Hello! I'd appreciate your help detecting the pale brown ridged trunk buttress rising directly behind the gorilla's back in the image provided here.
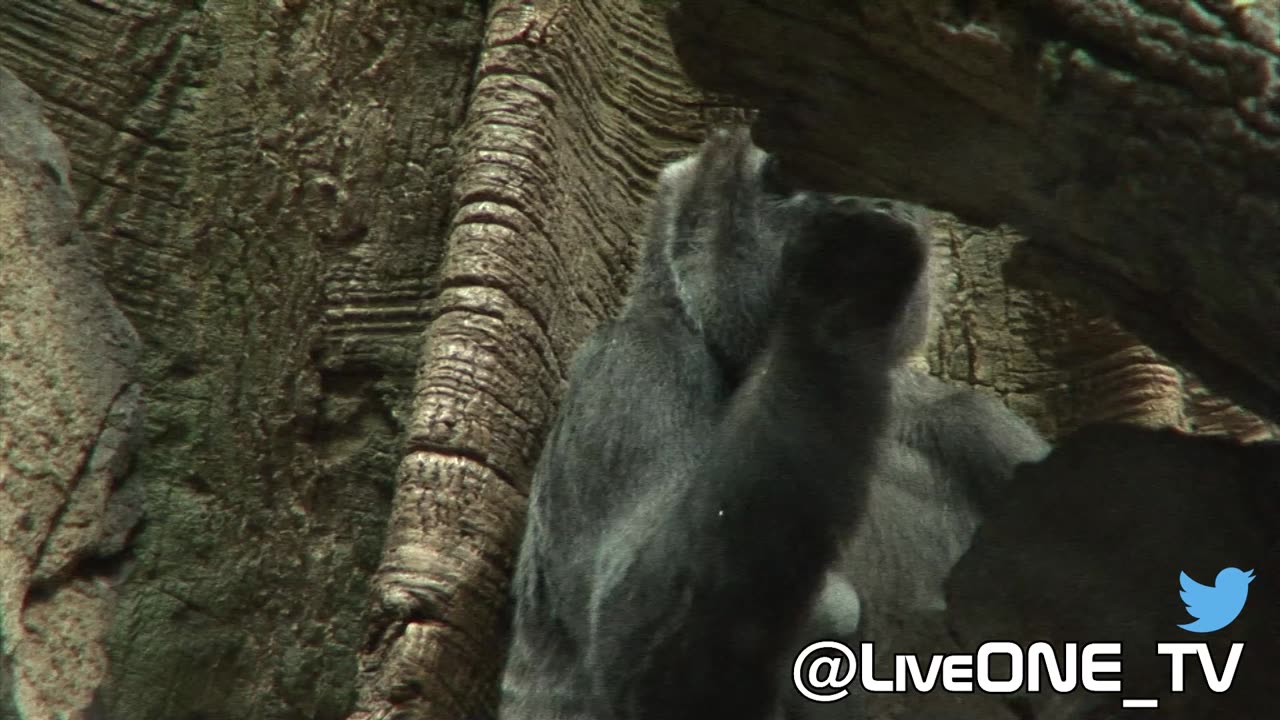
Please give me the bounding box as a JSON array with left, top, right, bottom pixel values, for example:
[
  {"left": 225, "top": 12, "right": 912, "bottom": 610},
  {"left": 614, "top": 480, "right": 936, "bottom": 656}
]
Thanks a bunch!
[{"left": 355, "top": 1, "right": 721, "bottom": 720}]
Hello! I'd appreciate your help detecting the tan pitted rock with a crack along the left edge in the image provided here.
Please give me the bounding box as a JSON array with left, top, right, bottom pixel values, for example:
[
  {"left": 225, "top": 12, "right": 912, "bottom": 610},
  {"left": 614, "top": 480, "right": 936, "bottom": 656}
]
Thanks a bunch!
[{"left": 0, "top": 68, "right": 142, "bottom": 720}]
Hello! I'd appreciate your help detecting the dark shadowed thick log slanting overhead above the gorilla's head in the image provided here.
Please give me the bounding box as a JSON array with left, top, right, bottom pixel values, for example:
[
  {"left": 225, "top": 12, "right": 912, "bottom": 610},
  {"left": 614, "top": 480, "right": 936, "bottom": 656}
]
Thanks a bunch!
[{"left": 672, "top": 0, "right": 1280, "bottom": 419}]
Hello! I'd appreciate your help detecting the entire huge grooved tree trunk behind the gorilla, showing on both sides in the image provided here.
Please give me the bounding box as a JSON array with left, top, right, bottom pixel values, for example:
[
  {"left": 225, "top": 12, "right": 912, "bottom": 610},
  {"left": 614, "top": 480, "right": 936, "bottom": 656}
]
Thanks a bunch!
[{"left": 0, "top": 0, "right": 1274, "bottom": 720}]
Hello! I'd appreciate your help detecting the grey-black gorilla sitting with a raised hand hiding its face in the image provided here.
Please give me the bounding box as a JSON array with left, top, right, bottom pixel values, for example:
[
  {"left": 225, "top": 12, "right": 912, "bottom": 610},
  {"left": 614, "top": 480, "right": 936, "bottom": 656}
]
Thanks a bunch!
[{"left": 500, "top": 132, "right": 1044, "bottom": 720}]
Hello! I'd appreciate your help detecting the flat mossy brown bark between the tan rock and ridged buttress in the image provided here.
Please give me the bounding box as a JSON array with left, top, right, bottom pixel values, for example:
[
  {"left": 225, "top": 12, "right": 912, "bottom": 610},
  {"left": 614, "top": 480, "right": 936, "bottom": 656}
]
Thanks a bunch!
[{"left": 0, "top": 0, "right": 484, "bottom": 720}]
